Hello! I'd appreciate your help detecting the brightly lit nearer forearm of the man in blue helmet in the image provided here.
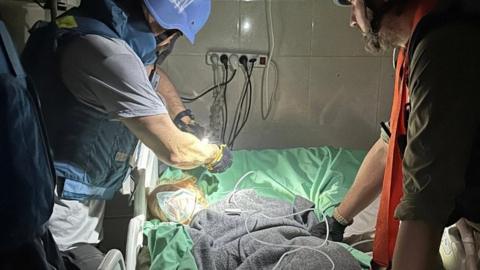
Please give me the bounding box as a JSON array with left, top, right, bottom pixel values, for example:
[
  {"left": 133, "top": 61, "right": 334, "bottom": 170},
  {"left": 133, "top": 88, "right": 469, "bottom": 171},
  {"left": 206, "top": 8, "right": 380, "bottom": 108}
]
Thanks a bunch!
[{"left": 122, "top": 114, "right": 220, "bottom": 169}]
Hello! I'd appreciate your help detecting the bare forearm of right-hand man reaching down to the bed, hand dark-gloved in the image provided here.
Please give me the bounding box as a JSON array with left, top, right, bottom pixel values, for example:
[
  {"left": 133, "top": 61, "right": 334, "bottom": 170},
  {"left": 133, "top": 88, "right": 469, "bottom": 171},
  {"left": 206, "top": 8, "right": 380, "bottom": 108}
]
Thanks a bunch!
[{"left": 337, "top": 139, "right": 387, "bottom": 220}]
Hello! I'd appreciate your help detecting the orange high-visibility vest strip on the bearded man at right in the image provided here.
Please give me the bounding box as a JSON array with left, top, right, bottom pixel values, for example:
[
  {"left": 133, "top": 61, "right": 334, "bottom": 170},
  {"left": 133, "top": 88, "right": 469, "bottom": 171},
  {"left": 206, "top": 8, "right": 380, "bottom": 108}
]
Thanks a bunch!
[{"left": 373, "top": 0, "right": 436, "bottom": 267}]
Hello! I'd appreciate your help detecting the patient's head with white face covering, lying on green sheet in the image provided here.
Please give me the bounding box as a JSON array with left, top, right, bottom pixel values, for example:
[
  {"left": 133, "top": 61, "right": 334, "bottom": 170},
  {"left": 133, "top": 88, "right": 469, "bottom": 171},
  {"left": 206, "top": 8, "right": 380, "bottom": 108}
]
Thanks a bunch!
[{"left": 147, "top": 176, "right": 208, "bottom": 224}]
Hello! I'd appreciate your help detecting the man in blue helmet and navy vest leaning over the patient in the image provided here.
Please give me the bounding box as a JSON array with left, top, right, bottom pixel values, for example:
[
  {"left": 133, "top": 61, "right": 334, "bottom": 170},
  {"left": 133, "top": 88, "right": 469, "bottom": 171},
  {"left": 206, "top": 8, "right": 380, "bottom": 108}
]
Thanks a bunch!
[{"left": 22, "top": 0, "right": 231, "bottom": 269}]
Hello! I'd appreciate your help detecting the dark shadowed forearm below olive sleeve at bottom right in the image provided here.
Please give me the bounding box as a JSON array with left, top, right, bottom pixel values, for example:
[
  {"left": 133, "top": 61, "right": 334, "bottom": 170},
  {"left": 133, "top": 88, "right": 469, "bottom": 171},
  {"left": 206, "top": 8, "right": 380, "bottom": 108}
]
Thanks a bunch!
[{"left": 392, "top": 220, "right": 443, "bottom": 270}]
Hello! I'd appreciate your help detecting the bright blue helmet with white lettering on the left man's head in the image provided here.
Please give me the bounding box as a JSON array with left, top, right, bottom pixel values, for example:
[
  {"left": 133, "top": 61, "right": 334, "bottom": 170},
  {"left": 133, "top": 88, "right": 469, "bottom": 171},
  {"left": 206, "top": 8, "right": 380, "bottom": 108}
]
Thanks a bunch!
[{"left": 143, "top": 0, "right": 211, "bottom": 44}]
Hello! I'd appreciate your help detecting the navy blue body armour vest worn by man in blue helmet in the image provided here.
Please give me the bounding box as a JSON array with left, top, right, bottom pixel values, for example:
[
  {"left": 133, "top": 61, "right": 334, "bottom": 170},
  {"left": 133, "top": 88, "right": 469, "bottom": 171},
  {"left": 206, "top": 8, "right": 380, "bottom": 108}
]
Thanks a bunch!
[{"left": 22, "top": 0, "right": 156, "bottom": 200}]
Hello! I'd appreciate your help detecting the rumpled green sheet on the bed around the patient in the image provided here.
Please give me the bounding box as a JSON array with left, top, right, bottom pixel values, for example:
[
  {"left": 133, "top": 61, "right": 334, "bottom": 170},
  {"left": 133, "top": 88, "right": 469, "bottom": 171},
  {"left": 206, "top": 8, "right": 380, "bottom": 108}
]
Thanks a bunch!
[{"left": 144, "top": 147, "right": 371, "bottom": 269}]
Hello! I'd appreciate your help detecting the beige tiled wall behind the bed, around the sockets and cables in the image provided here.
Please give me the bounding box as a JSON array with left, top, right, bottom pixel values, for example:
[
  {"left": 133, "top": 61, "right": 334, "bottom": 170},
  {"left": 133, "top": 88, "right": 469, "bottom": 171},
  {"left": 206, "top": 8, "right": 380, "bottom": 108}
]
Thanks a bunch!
[{"left": 164, "top": 0, "right": 393, "bottom": 149}]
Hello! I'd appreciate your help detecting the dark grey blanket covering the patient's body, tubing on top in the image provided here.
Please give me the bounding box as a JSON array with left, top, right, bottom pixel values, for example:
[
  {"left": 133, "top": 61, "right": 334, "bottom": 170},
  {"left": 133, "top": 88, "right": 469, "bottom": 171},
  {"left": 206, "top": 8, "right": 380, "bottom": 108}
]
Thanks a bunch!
[{"left": 188, "top": 190, "right": 360, "bottom": 270}]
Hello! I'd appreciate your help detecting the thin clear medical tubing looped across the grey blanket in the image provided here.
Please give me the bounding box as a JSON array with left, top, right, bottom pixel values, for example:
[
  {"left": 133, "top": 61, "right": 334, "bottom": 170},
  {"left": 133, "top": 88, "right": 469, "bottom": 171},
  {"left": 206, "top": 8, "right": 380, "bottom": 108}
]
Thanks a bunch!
[{"left": 228, "top": 171, "right": 335, "bottom": 270}]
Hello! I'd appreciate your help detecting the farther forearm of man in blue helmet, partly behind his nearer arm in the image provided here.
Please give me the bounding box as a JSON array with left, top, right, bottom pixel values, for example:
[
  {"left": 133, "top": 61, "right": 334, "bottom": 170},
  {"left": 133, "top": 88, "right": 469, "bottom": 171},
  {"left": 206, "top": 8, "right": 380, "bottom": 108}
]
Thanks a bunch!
[{"left": 147, "top": 67, "right": 185, "bottom": 118}]
